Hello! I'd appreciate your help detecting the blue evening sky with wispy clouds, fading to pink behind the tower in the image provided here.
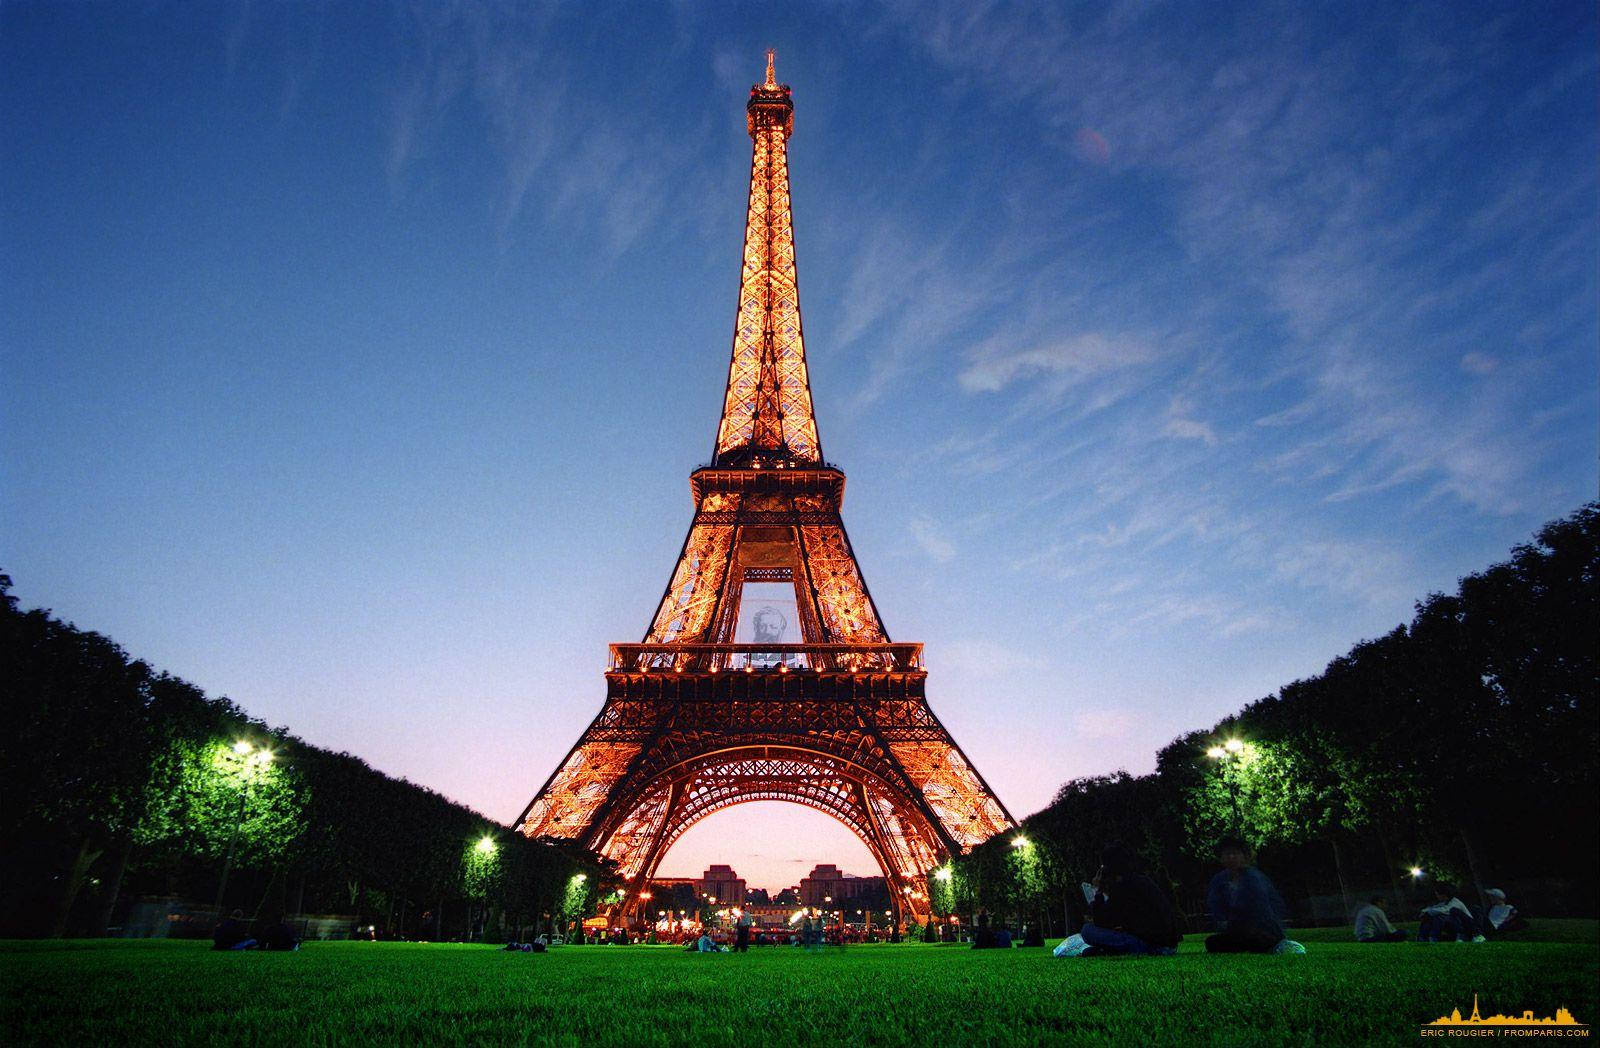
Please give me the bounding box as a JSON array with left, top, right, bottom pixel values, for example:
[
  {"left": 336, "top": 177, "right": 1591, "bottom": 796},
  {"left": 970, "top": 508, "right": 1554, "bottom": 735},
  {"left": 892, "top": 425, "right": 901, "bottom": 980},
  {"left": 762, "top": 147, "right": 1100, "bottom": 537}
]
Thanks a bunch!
[{"left": 0, "top": 2, "right": 1600, "bottom": 886}]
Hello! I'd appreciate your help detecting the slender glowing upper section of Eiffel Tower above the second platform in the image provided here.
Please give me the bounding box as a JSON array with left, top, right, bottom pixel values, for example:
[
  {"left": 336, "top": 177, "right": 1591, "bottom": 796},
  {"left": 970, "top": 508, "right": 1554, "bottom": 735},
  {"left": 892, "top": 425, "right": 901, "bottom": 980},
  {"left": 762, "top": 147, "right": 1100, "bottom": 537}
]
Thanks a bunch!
[{"left": 714, "top": 50, "right": 822, "bottom": 469}]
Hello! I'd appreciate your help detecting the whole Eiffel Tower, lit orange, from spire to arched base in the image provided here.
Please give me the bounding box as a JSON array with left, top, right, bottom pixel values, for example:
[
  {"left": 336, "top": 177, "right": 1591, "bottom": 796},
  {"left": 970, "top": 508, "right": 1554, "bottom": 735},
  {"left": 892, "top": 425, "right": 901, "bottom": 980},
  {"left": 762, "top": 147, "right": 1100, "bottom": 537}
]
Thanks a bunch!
[{"left": 517, "top": 51, "right": 1014, "bottom": 918}]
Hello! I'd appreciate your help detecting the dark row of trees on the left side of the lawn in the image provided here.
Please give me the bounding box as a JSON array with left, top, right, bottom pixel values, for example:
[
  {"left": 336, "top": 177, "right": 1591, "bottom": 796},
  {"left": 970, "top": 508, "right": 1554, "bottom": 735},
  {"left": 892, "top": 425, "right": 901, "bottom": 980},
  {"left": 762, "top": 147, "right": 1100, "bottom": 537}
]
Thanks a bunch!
[{"left": 0, "top": 574, "right": 613, "bottom": 939}]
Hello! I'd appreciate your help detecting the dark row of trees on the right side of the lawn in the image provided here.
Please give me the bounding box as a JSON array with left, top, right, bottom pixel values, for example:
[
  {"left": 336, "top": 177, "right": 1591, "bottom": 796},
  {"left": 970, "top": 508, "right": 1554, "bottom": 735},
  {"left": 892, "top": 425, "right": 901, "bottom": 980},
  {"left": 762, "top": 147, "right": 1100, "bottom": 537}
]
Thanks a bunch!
[{"left": 933, "top": 504, "right": 1600, "bottom": 928}]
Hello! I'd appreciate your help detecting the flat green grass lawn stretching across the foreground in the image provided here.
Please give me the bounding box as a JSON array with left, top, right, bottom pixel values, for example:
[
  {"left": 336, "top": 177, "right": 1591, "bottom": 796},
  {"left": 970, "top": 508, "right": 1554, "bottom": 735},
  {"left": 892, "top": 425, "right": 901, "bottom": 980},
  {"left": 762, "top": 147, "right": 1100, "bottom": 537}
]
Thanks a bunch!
[{"left": 0, "top": 922, "right": 1600, "bottom": 1048}]
